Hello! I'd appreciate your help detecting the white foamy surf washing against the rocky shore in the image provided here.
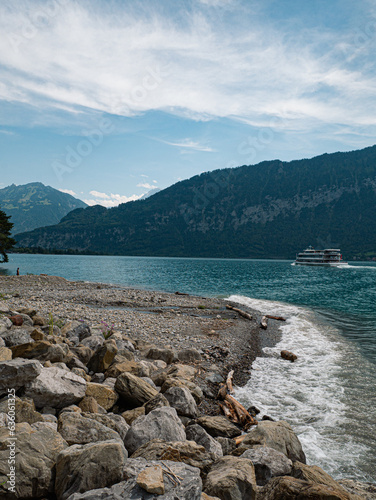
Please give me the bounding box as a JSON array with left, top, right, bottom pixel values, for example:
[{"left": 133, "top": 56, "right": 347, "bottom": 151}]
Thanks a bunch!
[{"left": 229, "top": 295, "right": 376, "bottom": 481}]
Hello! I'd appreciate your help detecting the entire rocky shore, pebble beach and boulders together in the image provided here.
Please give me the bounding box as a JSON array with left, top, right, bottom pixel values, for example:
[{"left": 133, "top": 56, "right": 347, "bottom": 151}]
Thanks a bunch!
[{"left": 0, "top": 275, "right": 376, "bottom": 500}]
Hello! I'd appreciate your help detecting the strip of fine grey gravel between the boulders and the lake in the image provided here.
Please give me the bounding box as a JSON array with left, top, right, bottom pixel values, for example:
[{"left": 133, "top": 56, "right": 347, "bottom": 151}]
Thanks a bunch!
[{"left": 0, "top": 275, "right": 280, "bottom": 408}]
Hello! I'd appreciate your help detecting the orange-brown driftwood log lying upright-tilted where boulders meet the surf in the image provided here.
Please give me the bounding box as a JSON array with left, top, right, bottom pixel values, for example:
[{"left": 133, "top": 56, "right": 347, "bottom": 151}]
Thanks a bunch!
[{"left": 217, "top": 370, "right": 257, "bottom": 430}]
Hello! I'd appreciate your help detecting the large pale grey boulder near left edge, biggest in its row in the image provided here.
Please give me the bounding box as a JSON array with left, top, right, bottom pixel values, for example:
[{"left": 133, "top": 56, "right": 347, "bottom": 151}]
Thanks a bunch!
[{"left": 24, "top": 366, "right": 86, "bottom": 408}]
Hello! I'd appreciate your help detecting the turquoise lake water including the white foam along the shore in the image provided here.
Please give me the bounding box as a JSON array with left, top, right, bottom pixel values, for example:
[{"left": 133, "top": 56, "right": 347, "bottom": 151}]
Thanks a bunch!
[{"left": 0, "top": 254, "right": 376, "bottom": 481}]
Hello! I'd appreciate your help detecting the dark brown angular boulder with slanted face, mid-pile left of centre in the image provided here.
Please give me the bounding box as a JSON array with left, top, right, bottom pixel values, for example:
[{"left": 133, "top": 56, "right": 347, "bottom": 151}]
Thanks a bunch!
[{"left": 115, "top": 372, "right": 158, "bottom": 408}]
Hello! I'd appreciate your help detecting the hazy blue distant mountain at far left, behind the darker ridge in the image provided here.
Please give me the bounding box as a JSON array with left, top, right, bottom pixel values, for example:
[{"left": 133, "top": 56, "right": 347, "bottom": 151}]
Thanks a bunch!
[{"left": 0, "top": 182, "right": 87, "bottom": 234}]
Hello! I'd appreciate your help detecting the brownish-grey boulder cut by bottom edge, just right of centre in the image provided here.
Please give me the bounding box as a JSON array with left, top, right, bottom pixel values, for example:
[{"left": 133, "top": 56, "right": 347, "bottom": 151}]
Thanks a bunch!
[{"left": 204, "top": 456, "right": 257, "bottom": 500}]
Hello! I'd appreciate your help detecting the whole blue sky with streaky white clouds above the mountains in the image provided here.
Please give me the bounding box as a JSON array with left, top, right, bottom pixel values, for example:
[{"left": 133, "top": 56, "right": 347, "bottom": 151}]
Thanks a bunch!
[{"left": 0, "top": 0, "right": 376, "bottom": 207}]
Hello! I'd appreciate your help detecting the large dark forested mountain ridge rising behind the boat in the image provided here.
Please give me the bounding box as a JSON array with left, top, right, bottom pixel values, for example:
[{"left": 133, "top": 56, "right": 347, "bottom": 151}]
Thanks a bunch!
[{"left": 16, "top": 146, "right": 376, "bottom": 259}]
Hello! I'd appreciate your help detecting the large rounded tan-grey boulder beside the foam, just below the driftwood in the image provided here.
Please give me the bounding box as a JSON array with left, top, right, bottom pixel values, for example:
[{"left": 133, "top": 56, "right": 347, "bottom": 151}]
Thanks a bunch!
[{"left": 236, "top": 420, "right": 306, "bottom": 463}]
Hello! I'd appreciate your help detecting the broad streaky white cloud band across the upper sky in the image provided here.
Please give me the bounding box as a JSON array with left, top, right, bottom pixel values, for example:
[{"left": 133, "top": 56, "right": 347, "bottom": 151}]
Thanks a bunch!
[{"left": 0, "top": 0, "right": 376, "bottom": 135}]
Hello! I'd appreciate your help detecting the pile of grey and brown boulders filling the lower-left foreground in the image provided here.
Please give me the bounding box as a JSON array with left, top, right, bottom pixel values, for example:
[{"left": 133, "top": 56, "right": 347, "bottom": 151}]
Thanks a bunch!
[{"left": 0, "top": 280, "right": 370, "bottom": 500}]
